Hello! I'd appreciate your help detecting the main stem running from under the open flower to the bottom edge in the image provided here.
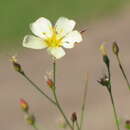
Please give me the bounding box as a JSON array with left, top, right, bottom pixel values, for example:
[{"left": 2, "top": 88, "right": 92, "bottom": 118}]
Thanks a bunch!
[{"left": 53, "top": 59, "right": 73, "bottom": 130}]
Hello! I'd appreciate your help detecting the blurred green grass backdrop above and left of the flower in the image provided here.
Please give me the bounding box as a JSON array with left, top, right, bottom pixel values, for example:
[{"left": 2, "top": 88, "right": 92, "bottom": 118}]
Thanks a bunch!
[{"left": 0, "top": 0, "right": 128, "bottom": 50}]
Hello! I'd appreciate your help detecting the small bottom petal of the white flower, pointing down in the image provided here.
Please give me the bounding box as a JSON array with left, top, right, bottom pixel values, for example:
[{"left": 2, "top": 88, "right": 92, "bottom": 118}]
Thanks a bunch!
[{"left": 47, "top": 47, "right": 65, "bottom": 59}]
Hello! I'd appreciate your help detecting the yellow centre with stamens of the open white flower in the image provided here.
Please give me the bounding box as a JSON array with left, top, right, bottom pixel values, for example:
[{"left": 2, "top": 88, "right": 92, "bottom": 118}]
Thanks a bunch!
[{"left": 45, "top": 28, "right": 62, "bottom": 48}]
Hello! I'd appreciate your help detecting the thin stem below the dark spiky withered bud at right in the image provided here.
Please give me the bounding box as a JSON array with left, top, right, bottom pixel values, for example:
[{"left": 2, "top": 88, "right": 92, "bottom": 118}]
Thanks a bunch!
[{"left": 109, "top": 90, "right": 120, "bottom": 130}]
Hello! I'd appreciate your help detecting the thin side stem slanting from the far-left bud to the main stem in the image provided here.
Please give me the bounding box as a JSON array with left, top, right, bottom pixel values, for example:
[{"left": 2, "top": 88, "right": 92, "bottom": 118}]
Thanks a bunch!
[{"left": 21, "top": 73, "right": 56, "bottom": 105}]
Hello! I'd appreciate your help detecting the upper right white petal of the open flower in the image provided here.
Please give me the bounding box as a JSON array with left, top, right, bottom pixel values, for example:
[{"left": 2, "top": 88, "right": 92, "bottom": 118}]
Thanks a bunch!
[{"left": 55, "top": 17, "right": 76, "bottom": 37}]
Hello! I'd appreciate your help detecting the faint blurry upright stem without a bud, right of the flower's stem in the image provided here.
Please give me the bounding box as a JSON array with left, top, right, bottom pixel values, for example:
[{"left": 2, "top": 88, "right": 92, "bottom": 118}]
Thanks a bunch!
[{"left": 80, "top": 76, "right": 88, "bottom": 130}]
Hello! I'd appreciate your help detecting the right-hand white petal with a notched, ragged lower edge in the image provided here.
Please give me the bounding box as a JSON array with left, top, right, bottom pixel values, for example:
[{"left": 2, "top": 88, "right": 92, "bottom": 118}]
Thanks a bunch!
[{"left": 62, "top": 31, "right": 82, "bottom": 48}]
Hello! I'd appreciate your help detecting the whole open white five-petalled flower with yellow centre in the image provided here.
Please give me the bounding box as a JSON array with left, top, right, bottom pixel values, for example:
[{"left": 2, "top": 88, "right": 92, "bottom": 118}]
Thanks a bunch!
[{"left": 23, "top": 17, "right": 82, "bottom": 59}]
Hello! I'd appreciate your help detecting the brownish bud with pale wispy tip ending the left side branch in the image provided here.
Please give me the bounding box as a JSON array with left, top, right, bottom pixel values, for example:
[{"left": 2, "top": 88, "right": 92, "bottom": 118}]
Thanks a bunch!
[{"left": 11, "top": 56, "right": 24, "bottom": 74}]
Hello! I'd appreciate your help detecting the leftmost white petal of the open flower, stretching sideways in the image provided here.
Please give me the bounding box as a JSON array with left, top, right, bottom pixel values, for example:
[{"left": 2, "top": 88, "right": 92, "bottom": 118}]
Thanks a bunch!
[{"left": 23, "top": 35, "right": 46, "bottom": 49}]
